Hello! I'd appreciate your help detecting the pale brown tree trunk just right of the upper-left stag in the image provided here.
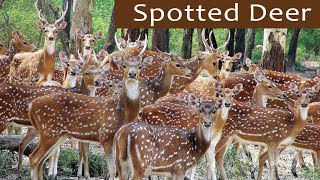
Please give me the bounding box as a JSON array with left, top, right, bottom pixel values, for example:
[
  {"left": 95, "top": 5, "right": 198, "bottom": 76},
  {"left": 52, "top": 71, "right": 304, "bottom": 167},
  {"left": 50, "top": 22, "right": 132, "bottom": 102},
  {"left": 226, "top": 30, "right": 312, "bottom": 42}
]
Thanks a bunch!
[{"left": 70, "top": 0, "right": 93, "bottom": 57}]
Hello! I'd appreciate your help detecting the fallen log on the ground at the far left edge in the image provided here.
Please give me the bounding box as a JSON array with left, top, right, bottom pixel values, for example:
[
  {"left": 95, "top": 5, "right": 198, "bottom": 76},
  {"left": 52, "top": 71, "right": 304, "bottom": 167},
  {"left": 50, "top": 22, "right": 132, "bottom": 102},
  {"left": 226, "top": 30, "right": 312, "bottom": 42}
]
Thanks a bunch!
[{"left": 0, "top": 135, "right": 38, "bottom": 156}]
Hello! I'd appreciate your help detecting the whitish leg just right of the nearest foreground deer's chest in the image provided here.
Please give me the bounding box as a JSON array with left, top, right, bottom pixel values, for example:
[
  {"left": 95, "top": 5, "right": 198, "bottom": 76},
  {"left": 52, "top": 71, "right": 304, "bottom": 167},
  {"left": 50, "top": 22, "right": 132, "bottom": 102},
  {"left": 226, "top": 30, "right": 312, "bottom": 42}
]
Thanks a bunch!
[{"left": 205, "top": 143, "right": 217, "bottom": 180}]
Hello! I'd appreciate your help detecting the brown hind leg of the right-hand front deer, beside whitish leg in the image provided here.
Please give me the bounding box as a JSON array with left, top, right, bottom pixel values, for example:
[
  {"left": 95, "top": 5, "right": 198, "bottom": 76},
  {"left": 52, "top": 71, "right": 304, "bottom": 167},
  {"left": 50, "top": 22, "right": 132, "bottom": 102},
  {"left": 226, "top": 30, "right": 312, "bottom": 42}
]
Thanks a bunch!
[{"left": 216, "top": 138, "right": 232, "bottom": 180}]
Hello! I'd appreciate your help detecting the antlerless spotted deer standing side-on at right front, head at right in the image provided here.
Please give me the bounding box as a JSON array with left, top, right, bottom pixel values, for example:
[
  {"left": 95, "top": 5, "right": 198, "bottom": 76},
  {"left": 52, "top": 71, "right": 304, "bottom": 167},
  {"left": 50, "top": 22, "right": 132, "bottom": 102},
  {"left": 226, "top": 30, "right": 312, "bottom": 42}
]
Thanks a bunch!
[{"left": 216, "top": 83, "right": 319, "bottom": 179}]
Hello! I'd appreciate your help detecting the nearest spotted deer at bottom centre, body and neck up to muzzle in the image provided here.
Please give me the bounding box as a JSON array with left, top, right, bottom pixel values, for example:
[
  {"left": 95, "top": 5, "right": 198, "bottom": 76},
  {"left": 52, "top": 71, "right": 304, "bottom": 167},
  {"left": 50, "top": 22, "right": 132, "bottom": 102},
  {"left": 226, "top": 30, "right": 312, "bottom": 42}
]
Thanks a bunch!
[{"left": 114, "top": 118, "right": 212, "bottom": 180}]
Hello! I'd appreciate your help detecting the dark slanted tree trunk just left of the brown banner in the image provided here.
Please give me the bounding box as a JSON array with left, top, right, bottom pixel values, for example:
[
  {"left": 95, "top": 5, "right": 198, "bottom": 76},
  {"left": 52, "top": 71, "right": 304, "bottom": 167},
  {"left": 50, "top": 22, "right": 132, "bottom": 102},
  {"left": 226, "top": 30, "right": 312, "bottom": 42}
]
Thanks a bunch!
[{"left": 103, "top": 7, "right": 117, "bottom": 53}]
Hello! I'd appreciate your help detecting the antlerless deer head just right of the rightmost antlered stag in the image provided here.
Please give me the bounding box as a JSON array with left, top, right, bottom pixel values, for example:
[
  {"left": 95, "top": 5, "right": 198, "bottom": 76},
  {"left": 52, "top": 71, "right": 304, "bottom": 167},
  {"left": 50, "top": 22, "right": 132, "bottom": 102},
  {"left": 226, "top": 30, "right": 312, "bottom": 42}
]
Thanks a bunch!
[{"left": 219, "top": 51, "right": 242, "bottom": 80}]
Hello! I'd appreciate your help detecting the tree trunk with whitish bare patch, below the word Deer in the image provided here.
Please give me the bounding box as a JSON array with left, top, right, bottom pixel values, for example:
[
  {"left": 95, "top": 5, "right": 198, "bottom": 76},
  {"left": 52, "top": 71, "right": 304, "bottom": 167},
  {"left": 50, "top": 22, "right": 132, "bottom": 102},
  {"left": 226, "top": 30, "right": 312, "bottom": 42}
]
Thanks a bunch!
[{"left": 261, "top": 29, "right": 287, "bottom": 72}]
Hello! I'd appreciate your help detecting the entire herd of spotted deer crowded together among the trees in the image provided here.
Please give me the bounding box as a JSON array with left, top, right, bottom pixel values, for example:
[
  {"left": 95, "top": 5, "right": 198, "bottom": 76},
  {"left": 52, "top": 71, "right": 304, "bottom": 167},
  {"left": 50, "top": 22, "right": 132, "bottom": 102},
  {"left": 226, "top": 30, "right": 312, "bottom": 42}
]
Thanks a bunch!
[{"left": 0, "top": 1, "right": 320, "bottom": 179}]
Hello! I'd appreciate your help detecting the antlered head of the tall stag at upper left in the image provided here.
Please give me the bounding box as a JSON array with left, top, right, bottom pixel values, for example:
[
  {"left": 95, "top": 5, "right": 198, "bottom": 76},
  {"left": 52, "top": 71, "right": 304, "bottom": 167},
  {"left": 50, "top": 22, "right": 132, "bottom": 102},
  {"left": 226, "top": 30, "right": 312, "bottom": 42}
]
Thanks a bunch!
[{"left": 35, "top": 0, "right": 68, "bottom": 47}]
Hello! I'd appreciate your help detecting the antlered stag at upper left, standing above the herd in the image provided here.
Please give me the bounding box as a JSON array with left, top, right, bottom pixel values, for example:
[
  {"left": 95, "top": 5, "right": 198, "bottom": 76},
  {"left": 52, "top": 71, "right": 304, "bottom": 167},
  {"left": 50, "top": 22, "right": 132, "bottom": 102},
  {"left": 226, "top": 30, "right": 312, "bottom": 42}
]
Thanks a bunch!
[{"left": 9, "top": 2, "right": 68, "bottom": 85}]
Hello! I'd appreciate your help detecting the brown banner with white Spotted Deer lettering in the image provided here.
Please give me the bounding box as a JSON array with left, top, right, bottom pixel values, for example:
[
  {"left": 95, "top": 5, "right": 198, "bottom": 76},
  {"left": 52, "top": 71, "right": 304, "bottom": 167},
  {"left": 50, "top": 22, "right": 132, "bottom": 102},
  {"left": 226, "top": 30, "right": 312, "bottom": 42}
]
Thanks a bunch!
[{"left": 115, "top": 0, "right": 320, "bottom": 28}]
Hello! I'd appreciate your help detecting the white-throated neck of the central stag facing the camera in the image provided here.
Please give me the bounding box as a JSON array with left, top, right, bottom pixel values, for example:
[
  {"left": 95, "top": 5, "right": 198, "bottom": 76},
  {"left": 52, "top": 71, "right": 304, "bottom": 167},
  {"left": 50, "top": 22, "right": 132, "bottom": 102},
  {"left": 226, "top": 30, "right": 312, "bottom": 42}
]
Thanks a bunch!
[{"left": 120, "top": 79, "right": 141, "bottom": 123}]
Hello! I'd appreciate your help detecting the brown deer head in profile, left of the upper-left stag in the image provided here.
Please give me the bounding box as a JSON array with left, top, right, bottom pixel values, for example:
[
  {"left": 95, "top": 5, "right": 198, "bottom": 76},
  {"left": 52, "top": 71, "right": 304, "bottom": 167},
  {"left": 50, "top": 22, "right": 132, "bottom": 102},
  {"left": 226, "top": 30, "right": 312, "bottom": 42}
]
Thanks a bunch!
[{"left": 10, "top": 29, "right": 37, "bottom": 54}]
